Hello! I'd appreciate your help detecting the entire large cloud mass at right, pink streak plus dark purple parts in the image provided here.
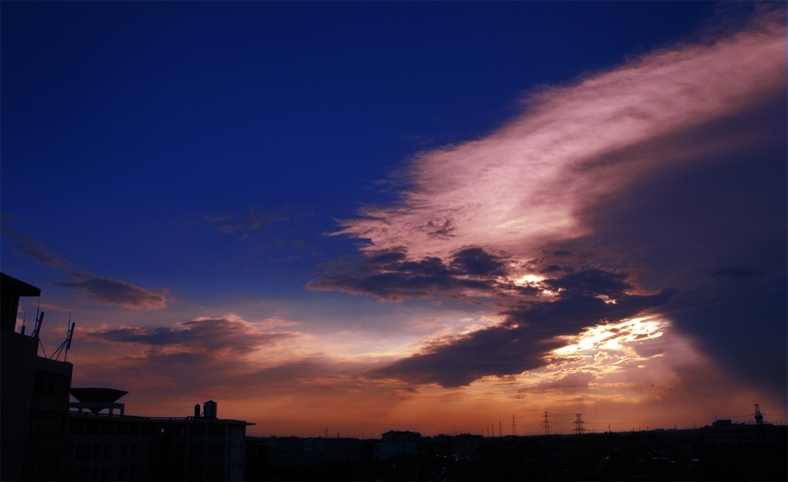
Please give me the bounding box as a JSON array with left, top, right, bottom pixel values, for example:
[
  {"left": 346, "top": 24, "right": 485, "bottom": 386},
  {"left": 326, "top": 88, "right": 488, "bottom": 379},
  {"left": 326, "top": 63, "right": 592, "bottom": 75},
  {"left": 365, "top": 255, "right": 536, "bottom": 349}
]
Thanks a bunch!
[{"left": 318, "top": 9, "right": 788, "bottom": 398}]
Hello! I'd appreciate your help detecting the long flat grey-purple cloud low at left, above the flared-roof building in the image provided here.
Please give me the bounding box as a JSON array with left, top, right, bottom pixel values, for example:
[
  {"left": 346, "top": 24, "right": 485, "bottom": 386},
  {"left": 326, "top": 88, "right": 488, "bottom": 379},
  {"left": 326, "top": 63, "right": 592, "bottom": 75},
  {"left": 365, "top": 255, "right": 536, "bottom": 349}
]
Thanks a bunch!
[{"left": 90, "top": 318, "right": 298, "bottom": 356}]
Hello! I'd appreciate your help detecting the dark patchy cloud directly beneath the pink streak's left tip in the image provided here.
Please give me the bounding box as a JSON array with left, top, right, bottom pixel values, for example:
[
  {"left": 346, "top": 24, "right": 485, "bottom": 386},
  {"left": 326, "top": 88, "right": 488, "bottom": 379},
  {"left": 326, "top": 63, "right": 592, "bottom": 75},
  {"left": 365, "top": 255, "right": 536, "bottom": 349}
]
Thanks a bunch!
[{"left": 307, "top": 247, "right": 516, "bottom": 301}]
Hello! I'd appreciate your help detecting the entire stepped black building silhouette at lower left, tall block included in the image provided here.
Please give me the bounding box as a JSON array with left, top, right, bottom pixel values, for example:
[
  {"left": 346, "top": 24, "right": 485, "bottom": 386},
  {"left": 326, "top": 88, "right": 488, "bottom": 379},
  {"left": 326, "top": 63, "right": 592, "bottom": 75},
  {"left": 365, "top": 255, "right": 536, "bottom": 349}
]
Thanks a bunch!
[{"left": 0, "top": 274, "right": 253, "bottom": 481}]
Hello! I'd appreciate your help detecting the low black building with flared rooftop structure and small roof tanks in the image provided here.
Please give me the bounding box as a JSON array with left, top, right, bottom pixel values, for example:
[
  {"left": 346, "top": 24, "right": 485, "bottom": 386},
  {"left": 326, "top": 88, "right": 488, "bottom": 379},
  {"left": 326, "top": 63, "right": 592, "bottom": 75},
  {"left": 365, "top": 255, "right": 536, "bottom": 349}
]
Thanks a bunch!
[{"left": 64, "top": 394, "right": 253, "bottom": 480}]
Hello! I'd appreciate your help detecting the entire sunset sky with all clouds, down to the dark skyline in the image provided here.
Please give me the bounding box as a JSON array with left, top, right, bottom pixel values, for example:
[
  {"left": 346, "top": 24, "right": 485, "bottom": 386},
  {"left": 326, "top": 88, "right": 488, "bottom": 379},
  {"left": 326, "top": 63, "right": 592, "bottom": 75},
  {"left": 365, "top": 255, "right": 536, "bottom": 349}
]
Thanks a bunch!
[{"left": 0, "top": 1, "right": 788, "bottom": 438}]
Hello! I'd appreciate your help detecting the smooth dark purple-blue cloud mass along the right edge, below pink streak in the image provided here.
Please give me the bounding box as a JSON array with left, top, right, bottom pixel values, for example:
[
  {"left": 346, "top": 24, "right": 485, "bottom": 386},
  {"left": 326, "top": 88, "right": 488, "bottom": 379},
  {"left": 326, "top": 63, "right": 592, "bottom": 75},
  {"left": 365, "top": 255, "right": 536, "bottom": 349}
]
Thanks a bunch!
[{"left": 572, "top": 94, "right": 788, "bottom": 400}]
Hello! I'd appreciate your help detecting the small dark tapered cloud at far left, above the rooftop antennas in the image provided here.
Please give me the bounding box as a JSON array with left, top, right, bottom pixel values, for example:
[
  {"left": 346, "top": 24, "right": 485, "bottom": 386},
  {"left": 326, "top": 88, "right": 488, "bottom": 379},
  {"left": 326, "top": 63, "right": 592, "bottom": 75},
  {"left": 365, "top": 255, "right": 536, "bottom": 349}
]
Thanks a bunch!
[{"left": 55, "top": 273, "right": 167, "bottom": 309}]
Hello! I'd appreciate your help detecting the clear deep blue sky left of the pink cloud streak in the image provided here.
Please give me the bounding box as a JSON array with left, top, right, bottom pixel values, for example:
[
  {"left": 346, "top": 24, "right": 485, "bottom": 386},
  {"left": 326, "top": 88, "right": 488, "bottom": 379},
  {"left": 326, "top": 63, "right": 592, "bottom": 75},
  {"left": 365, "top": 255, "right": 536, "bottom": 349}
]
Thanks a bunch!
[{"left": 2, "top": 2, "right": 714, "bottom": 296}]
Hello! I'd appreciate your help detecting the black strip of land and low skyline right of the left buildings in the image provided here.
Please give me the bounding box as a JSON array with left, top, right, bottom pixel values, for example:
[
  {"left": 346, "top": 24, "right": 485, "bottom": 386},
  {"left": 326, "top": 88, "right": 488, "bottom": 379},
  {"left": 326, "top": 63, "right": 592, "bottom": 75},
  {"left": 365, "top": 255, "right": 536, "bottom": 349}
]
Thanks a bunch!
[{"left": 246, "top": 426, "right": 788, "bottom": 481}]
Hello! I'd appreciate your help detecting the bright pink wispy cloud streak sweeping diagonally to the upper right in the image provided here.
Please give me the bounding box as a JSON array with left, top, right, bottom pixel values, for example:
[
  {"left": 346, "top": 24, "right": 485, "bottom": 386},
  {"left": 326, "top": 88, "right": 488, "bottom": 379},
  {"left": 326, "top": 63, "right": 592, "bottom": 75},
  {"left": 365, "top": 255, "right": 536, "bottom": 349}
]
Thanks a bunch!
[{"left": 341, "top": 12, "right": 785, "bottom": 259}]
